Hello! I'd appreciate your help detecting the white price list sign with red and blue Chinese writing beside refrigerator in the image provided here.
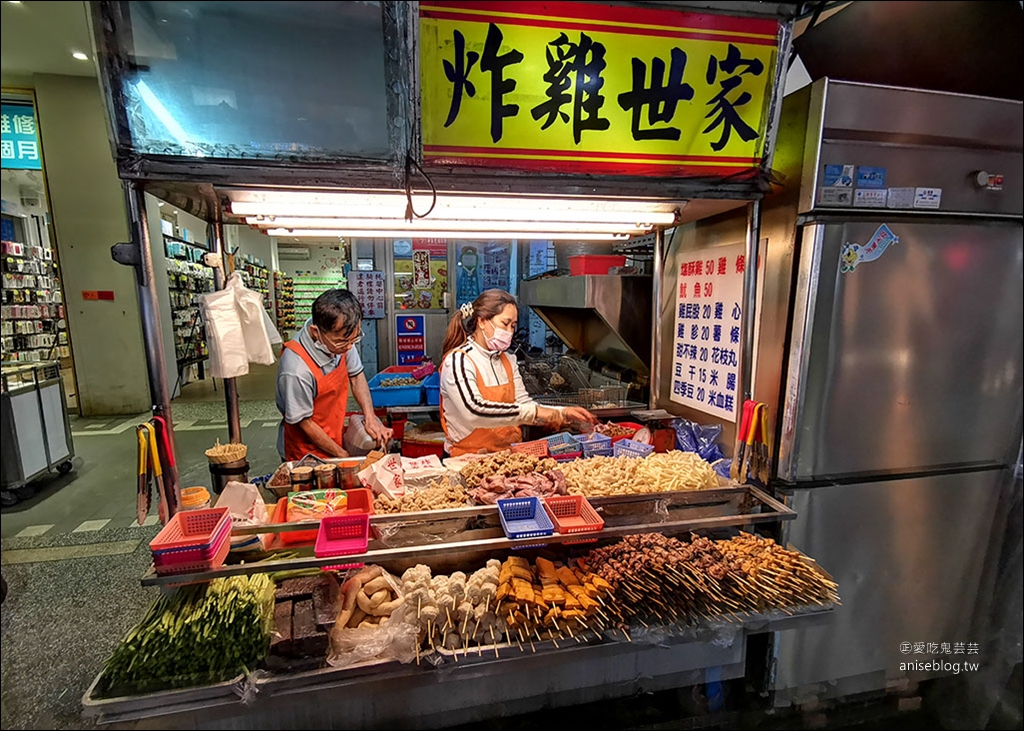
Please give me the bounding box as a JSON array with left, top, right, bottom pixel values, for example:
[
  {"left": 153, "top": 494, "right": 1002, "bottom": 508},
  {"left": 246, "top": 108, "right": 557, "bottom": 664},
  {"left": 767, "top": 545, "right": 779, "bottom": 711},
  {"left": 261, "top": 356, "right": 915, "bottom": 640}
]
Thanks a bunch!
[{"left": 670, "top": 244, "right": 745, "bottom": 421}]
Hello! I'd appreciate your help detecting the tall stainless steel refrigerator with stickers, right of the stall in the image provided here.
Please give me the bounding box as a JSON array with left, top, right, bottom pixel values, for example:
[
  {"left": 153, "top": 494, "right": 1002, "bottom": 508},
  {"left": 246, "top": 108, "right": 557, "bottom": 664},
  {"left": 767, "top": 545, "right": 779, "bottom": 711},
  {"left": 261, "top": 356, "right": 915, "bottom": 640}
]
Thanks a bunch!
[{"left": 755, "top": 80, "right": 1024, "bottom": 702}]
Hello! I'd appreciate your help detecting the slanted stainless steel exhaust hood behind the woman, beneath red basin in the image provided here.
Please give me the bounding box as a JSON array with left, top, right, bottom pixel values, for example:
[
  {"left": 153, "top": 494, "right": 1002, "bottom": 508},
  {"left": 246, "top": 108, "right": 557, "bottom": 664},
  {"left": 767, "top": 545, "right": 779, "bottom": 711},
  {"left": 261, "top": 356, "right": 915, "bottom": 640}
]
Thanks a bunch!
[{"left": 519, "top": 275, "right": 652, "bottom": 376}]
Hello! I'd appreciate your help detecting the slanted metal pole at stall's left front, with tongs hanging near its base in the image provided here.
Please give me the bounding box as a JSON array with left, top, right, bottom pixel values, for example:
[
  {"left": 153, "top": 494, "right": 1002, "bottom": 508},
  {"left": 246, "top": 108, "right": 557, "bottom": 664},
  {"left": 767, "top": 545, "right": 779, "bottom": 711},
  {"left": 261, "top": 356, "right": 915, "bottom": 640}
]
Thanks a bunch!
[{"left": 121, "top": 182, "right": 178, "bottom": 517}]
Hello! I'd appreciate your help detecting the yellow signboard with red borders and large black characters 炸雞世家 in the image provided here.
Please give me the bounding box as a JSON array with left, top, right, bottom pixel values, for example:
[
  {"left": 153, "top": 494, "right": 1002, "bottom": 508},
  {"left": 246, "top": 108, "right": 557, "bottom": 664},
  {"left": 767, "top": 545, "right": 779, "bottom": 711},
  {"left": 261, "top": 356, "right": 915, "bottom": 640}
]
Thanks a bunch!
[{"left": 420, "top": 0, "right": 778, "bottom": 176}]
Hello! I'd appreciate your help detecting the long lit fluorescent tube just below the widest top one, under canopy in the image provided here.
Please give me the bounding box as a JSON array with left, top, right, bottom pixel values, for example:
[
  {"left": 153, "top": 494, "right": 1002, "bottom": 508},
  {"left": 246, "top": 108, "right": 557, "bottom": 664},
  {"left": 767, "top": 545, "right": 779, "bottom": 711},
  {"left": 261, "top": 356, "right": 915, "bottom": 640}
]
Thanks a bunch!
[{"left": 246, "top": 216, "right": 652, "bottom": 237}]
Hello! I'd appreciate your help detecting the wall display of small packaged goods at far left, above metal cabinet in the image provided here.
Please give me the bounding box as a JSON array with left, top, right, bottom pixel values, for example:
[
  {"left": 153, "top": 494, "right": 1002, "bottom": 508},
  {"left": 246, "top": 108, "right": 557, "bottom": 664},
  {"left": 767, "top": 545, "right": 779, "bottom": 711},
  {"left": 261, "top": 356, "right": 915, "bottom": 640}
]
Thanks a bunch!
[{"left": 0, "top": 241, "right": 71, "bottom": 362}]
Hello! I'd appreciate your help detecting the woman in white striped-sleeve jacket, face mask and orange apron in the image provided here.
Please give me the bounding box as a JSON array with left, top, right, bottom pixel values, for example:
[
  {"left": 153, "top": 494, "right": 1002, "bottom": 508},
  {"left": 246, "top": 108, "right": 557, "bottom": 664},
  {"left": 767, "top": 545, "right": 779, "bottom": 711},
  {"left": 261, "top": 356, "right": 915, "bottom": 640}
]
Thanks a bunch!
[{"left": 440, "top": 290, "right": 597, "bottom": 457}]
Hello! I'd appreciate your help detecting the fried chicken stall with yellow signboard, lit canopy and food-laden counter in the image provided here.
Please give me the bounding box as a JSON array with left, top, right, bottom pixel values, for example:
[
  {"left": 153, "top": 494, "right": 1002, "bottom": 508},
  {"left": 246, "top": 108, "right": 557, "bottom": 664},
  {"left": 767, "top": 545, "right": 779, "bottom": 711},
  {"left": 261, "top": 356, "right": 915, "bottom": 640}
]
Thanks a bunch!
[{"left": 70, "top": 1, "right": 864, "bottom": 728}]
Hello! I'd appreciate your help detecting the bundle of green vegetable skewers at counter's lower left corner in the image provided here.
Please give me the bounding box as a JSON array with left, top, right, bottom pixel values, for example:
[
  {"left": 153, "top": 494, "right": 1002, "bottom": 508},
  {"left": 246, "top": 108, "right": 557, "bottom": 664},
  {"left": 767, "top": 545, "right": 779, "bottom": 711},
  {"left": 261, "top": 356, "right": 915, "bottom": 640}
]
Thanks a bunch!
[{"left": 101, "top": 573, "right": 274, "bottom": 695}]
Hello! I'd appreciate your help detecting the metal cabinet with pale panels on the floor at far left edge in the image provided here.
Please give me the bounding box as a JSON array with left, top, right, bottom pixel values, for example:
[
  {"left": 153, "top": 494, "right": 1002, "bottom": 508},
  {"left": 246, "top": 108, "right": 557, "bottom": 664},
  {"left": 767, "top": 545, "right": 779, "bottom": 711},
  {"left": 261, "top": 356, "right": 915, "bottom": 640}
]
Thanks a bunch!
[{"left": 0, "top": 360, "right": 75, "bottom": 505}]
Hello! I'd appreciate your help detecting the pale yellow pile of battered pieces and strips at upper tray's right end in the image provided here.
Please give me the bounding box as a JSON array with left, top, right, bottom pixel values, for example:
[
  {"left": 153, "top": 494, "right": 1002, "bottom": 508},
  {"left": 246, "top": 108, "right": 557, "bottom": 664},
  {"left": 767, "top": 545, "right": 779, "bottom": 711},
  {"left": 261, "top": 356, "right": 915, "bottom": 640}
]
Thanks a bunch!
[{"left": 562, "top": 452, "right": 719, "bottom": 497}]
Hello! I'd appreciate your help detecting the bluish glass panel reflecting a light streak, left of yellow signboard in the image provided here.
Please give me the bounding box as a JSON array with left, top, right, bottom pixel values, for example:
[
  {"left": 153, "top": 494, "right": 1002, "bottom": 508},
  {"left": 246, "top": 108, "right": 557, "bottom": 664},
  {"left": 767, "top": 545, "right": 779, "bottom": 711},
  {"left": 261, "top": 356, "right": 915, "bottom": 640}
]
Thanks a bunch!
[{"left": 119, "top": 0, "right": 389, "bottom": 161}]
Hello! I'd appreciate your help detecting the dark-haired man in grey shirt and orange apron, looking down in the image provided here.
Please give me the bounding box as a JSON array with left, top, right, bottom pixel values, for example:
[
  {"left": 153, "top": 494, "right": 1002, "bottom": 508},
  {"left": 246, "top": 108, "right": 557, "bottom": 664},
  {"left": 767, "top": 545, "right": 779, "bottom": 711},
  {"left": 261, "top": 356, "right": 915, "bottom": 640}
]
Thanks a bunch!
[{"left": 276, "top": 290, "right": 391, "bottom": 462}]
